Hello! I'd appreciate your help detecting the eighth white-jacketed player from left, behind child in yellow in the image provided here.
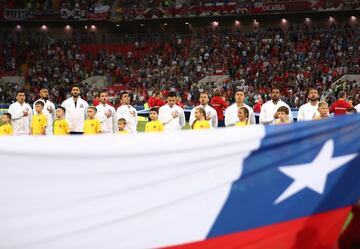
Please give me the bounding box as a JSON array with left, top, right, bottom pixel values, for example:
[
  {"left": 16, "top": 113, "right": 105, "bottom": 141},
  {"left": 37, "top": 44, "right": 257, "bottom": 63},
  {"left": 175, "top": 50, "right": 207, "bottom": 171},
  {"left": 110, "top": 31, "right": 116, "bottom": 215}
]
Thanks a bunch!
[{"left": 225, "top": 91, "right": 256, "bottom": 126}]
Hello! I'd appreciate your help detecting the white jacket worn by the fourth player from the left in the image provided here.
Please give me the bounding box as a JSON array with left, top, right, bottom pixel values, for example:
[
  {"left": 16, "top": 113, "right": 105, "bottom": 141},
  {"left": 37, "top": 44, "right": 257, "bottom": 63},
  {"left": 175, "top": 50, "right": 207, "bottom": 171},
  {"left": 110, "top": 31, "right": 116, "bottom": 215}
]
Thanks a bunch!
[{"left": 95, "top": 103, "right": 117, "bottom": 134}]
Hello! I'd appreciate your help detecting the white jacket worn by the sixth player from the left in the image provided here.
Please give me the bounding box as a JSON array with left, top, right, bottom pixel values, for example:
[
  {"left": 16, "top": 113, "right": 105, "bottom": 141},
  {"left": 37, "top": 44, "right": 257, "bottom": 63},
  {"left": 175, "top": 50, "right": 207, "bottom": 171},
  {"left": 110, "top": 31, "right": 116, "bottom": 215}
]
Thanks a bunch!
[{"left": 159, "top": 104, "right": 185, "bottom": 131}]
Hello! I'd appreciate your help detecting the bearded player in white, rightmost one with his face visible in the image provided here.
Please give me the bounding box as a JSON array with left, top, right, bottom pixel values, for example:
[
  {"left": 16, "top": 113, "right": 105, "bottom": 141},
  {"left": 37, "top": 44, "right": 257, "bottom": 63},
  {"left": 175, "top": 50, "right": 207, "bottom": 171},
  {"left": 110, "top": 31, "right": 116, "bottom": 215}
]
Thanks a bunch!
[{"left": 297, "top": 88, "right": 319, "bottom": 121}]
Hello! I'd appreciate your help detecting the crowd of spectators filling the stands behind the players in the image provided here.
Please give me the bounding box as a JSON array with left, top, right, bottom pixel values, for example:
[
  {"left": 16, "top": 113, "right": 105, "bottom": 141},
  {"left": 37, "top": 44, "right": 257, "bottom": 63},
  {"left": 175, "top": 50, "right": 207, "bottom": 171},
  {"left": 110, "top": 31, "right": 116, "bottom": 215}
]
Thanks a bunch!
[{"left": 0, "top": 22, "right": 360, "bottom": 108}]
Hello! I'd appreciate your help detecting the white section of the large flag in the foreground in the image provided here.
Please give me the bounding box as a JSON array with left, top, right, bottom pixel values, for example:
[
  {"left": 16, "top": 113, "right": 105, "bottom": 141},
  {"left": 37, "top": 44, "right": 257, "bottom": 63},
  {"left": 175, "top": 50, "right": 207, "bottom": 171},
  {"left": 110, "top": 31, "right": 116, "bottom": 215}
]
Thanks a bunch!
[{"left": 0, "top": 126, "right": 265, "bottom": 249}]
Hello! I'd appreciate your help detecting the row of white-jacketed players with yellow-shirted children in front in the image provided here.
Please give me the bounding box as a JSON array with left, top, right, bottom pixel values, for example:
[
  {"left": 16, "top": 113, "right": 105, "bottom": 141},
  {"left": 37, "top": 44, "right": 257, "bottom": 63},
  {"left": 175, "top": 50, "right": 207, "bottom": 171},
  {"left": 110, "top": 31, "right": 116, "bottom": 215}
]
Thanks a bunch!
[{"left": 0, "top": 85, "right": 360, "bottom": 135}]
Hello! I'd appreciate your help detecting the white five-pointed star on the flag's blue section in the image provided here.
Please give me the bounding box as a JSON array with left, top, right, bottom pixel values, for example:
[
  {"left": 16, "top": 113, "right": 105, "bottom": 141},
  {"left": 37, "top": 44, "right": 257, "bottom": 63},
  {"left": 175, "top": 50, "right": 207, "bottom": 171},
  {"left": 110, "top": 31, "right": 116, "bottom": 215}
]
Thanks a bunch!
[{"left": 274, "top": 140, "right": 358, "bottom": 205}]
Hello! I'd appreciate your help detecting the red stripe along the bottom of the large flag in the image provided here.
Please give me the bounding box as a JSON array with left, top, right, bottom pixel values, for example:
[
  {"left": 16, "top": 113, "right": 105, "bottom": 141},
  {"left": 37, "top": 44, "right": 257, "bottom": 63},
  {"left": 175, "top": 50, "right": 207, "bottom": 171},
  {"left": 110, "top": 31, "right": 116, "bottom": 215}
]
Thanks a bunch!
[{"left": 167, "top": 207, "right": 350, "bottom": 249}]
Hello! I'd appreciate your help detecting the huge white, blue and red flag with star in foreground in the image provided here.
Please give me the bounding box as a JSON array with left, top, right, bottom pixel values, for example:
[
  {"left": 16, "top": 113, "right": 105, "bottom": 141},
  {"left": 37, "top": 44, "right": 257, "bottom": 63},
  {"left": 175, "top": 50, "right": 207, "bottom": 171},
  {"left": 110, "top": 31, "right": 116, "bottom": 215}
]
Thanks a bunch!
[{"left": 0, "top": 115, "right": 360, "bottom": 249}]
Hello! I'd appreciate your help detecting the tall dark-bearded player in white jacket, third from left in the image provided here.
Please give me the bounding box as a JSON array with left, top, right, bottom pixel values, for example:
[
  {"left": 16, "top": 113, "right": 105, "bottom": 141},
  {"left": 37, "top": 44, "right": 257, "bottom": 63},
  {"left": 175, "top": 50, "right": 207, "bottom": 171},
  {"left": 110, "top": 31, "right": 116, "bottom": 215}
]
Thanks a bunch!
[{"left": 61, "top": 85, "right": 89, "bottom": 135}]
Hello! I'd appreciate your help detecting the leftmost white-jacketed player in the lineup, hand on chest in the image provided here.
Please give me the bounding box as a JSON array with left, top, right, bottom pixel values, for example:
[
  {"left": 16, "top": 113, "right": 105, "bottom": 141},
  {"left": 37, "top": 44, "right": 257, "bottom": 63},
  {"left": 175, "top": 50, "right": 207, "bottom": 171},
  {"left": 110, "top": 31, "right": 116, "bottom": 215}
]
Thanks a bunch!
[{"left": 9, "top": 91, "right": 32, "bottom": 135}]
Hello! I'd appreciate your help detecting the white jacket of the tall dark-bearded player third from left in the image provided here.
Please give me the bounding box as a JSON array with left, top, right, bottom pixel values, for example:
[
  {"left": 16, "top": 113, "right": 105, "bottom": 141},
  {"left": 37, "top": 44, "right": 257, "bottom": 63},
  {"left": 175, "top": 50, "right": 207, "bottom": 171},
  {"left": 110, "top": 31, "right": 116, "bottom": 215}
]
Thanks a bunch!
[{"left": 61, "top": 97, "right": 89, "bottom": 132}]
